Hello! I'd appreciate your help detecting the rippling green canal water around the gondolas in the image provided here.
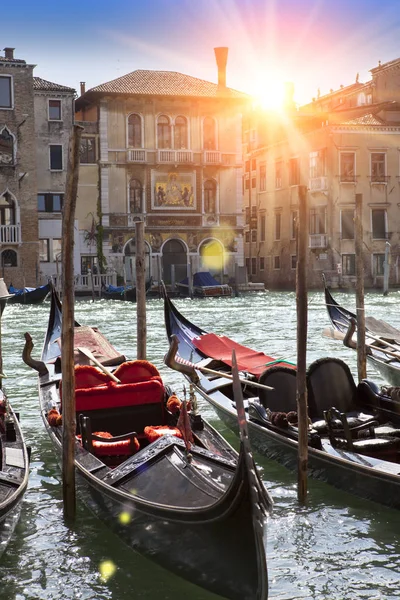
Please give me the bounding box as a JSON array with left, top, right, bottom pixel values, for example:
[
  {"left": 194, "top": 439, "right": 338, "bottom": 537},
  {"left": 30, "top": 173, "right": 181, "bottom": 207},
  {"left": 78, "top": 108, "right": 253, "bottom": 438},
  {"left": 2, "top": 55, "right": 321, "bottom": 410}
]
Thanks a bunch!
[{"left": 0, "top": 292, "right": 400, "bottom": 600}]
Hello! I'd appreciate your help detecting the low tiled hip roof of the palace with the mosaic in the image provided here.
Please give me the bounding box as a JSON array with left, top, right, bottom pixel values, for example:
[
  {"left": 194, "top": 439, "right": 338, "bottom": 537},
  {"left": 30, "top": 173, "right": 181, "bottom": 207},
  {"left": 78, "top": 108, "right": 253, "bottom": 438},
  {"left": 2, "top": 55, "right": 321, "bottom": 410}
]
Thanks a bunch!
[{"left": 86, "top": 70, "right": 249, "bottom": 99}]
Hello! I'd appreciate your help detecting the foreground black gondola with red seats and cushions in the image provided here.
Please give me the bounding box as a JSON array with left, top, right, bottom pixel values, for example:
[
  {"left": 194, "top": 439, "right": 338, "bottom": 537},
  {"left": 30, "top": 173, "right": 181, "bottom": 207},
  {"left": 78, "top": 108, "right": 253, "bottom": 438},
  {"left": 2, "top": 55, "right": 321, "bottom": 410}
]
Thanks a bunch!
[{"left": 24, "top": 290, "right": 271, "bottom": 600}]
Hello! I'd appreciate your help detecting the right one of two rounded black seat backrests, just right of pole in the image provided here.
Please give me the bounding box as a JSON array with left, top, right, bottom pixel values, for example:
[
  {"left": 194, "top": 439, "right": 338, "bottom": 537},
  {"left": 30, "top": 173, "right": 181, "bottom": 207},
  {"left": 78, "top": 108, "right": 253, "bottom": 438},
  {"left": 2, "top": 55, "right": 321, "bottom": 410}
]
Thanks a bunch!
[{"left": 307, "top": 358, "right": 358, "bottom": 419}]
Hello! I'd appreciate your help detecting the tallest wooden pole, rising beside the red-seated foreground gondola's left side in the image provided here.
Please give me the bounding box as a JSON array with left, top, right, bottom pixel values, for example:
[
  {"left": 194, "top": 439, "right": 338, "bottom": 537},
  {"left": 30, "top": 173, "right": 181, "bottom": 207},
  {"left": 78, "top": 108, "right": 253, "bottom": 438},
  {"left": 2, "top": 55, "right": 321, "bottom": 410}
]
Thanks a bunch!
[{"left": 61, "top": 125, "right": 83, "bottom": 522}]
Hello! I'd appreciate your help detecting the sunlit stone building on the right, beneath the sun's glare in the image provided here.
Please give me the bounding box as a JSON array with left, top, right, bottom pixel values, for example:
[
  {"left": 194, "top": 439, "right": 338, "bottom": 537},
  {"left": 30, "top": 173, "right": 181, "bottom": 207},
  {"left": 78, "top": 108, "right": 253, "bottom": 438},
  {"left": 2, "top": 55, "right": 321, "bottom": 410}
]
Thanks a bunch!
[{"left": 244, "top": 59, "right": 400, "bottom": 289}]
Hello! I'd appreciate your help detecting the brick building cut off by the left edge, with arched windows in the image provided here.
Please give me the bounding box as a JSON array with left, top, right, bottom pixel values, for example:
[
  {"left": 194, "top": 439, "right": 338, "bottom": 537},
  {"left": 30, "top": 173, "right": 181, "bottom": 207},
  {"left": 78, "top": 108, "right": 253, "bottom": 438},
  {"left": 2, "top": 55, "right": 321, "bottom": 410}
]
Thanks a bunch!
[{"left": 0, "top": 48, "right": 39, "bottom": 287}]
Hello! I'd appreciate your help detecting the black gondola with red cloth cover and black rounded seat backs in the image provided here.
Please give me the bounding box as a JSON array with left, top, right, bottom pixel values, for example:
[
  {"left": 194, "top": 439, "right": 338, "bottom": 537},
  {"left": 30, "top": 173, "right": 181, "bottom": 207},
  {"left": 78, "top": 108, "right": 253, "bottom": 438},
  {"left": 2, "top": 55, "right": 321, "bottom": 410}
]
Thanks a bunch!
[{"left": 164, "top": 291, "right": 400, "bottom": 509}]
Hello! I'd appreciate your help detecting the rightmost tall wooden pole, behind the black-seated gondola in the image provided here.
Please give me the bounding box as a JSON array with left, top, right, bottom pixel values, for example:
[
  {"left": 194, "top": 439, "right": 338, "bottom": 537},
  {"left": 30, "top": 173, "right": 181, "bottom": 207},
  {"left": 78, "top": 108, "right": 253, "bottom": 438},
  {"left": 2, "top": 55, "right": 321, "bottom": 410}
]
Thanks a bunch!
[{"left": 355, "top": 194, "right": 367, "bottom": 381}]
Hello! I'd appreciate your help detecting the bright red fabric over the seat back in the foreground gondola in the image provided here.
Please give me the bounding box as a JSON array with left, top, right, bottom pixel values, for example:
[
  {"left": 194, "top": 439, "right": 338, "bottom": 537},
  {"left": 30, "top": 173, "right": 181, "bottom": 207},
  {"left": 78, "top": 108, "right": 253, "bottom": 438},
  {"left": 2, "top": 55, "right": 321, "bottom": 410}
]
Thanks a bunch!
[{"left": 75, "top": 379, "right": 164, "bottom": 412}]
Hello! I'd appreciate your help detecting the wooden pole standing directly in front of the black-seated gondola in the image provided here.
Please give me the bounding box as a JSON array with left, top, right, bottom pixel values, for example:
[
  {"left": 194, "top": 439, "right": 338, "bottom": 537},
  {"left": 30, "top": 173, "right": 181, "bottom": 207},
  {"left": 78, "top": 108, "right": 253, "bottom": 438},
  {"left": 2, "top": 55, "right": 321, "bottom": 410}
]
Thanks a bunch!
[{"left": 296, "top": 185, "right": 308, "bottom": 503}]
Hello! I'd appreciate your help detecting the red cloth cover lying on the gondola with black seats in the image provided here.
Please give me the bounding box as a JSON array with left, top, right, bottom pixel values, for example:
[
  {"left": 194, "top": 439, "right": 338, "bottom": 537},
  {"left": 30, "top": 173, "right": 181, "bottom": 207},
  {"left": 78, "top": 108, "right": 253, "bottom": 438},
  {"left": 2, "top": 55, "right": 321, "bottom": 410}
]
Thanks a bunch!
[{"left": 193, "top": 333, "right": 296, "bottom": 377}]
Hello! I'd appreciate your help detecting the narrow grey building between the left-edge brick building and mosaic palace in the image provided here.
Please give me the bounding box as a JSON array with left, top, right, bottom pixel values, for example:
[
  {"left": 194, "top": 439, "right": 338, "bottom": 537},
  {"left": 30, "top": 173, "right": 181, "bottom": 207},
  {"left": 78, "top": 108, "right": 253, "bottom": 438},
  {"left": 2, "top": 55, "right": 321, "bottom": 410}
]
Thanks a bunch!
[{"left": 33, "top": 77, "right": 76, "bottom": 282}]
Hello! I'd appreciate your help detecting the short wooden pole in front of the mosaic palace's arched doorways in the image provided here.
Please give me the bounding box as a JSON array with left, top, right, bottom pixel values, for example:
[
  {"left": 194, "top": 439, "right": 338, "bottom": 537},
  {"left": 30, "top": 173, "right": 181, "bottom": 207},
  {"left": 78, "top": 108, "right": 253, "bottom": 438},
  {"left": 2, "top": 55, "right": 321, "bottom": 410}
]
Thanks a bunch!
[{"left": 135, "top": 221, "right": 147, "bottom": 360}]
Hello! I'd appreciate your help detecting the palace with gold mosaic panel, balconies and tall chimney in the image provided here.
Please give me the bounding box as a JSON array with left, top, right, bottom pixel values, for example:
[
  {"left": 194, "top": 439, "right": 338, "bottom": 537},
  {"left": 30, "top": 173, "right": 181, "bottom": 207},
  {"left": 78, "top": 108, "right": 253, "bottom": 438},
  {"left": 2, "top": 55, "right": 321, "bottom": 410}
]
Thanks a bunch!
[{"left": 76, "top": 48, "right": 248, "bottom": 283}]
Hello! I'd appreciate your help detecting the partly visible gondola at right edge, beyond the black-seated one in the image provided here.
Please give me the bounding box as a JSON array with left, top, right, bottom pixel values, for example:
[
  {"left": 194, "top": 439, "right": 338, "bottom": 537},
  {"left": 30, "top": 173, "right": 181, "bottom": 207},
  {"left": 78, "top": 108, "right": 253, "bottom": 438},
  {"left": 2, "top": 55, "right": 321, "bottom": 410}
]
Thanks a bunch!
[{"left": 323, "top": 277, "right": 400, "bottom": 386}]
